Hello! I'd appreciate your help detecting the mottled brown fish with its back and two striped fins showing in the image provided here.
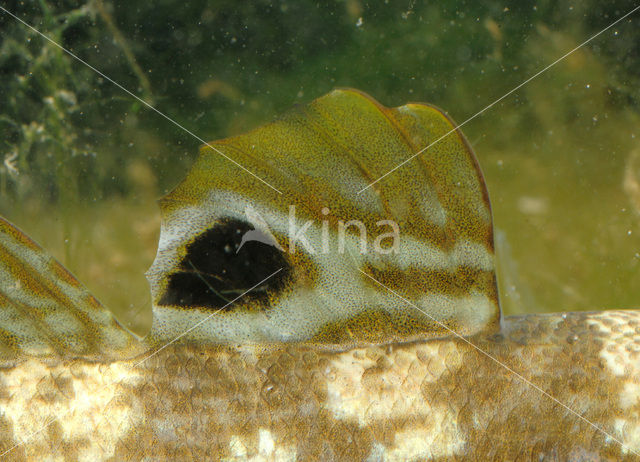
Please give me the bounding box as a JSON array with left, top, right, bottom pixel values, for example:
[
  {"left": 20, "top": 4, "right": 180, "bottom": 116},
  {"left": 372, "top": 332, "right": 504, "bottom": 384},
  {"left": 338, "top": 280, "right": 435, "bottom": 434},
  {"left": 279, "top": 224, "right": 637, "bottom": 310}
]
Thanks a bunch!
[{"left": 0, "top": 89, "right": 640, "bottom": 461}]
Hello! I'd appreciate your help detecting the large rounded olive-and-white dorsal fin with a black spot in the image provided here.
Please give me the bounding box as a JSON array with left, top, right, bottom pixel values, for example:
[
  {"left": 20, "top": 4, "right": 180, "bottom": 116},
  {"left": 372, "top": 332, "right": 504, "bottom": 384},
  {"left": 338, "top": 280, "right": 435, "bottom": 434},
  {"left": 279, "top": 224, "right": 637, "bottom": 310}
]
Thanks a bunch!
[{"left": 147, "top": 90, "right": 500, "bottom": 344}]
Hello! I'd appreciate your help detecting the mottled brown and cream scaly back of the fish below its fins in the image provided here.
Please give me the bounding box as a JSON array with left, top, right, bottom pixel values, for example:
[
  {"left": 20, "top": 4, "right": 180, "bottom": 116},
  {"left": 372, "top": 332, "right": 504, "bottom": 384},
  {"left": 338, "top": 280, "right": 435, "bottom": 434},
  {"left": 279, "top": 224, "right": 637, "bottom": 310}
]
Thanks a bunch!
[{"left": 0, "top": 311, "right": 640, "bottom": 461}]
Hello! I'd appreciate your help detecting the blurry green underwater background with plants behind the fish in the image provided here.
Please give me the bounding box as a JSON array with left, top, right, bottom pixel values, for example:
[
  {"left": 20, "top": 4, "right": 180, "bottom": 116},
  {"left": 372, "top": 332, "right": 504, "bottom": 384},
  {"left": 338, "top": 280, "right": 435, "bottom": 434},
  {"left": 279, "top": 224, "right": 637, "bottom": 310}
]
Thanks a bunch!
[{"left": 0, "top": 0, "right": 640, "bottom": 332}]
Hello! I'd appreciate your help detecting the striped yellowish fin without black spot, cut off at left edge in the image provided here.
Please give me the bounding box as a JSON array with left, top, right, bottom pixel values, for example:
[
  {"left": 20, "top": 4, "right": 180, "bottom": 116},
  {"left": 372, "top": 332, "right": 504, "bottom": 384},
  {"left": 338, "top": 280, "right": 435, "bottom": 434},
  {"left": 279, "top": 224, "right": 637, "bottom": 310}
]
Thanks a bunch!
[{"left": 0, "top": 217, "right": 138, "bottom": 364}]
